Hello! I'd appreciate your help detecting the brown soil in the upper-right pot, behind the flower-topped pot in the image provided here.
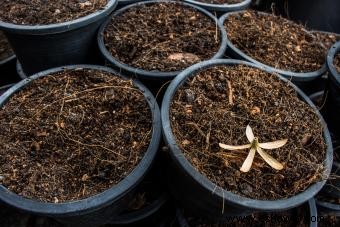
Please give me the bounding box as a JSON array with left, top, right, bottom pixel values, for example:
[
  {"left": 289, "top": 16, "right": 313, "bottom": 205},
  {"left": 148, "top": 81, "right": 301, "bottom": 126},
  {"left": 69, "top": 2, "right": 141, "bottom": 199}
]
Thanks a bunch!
[{"left": 224, "top": 11, "right": 326, "bottom": 72}]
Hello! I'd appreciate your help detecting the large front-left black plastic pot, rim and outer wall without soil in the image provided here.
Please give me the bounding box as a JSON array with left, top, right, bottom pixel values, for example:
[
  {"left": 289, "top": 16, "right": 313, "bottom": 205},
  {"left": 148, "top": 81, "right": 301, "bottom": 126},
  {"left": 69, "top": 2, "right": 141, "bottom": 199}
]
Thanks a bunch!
[{"left": 0, "top": 65, "right": 161, "bottom": 226}]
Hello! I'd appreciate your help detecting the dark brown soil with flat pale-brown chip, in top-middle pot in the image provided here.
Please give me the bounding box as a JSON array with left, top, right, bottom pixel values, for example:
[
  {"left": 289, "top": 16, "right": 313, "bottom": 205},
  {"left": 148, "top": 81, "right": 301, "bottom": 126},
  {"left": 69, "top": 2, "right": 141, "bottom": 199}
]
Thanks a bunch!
[{"left": 104, "top": 2, "right": 220, "bottom": 72}]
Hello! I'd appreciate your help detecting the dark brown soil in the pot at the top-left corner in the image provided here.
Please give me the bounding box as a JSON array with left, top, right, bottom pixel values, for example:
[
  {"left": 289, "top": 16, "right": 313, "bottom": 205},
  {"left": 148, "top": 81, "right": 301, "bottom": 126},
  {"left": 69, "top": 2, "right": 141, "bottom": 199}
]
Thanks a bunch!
[{"left": 0, "top": 0, "right": 108, "bottom": 25}]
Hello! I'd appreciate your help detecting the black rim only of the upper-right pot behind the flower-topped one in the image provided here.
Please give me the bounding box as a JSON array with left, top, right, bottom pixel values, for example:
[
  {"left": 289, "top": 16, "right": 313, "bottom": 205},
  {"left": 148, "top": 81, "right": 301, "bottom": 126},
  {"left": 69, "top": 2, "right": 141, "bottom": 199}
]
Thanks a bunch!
[{"left": 219, "top": 10, "right": 327, "bottom": 82}]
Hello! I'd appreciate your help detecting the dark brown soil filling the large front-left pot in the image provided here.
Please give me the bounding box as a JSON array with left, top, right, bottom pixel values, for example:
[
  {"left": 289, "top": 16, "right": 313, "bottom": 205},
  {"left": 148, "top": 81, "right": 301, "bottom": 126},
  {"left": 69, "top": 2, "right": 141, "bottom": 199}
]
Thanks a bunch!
[{"left": 0, "top": 69, "right": 151, "bottom": 203}]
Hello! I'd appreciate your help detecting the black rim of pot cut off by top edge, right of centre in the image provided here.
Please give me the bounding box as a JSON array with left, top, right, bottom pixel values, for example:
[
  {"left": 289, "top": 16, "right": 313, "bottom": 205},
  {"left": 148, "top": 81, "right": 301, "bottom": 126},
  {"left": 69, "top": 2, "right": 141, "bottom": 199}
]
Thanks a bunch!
[{"left": 184, "top": 0, "right": 252, "bottom": 12}]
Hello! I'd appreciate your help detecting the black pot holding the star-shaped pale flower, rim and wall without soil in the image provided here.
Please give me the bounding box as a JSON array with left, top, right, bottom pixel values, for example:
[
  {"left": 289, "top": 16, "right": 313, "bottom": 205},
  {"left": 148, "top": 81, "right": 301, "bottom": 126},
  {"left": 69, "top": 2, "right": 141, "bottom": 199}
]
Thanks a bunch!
[{"left": 161, "top": 59, "right": 333, "bottom": 220}]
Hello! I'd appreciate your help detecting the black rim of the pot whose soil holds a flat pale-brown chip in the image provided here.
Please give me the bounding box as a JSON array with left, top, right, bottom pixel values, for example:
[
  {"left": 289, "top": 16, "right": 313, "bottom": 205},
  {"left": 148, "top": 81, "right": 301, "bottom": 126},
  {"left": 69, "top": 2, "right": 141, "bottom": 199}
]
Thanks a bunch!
[{"left": 97, "top": 0, "right": 227, "bottom": 80}]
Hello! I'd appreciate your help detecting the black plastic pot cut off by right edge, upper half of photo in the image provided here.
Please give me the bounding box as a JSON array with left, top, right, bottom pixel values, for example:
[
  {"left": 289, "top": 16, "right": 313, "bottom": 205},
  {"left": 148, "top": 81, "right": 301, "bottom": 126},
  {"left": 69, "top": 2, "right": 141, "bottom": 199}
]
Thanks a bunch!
[{"left": 325, "top": 42, "right": 340, "bottom": 141}]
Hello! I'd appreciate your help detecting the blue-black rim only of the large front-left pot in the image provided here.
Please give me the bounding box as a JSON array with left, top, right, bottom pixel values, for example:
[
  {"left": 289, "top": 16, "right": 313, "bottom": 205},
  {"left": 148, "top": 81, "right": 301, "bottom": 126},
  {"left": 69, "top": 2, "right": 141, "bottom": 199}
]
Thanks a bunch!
[{"left": 0, "top": 65, "right": 161, "bottom": 217}]
